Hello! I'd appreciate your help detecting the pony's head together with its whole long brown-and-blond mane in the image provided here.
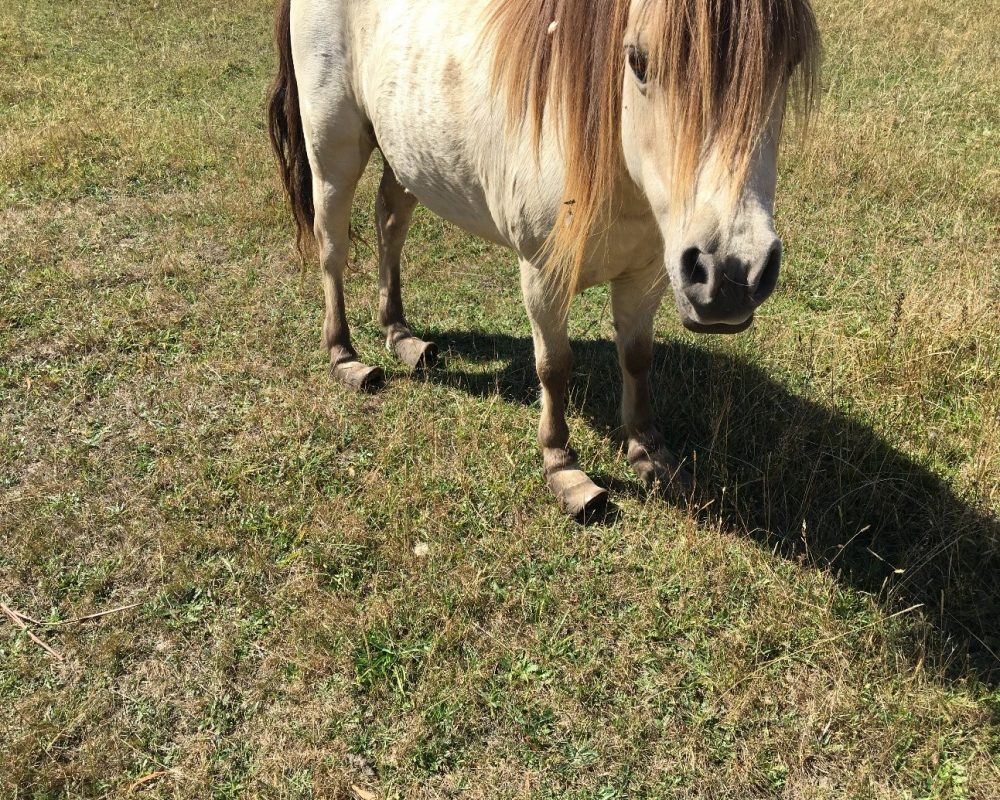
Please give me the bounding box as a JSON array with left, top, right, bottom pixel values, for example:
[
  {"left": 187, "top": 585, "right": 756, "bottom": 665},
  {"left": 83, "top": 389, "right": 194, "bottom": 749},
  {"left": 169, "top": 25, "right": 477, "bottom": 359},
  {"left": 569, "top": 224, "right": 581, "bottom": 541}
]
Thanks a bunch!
[{"left": 486, "top": 0, "right": 818, "bottom": 333}]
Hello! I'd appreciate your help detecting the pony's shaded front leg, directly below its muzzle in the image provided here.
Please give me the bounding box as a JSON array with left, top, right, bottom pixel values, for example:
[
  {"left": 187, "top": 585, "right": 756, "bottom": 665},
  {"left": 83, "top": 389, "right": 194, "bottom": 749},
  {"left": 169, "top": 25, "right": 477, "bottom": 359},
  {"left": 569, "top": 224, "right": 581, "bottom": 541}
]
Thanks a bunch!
[{"left": 611, "top": 269, "right": 693, "bottom": 489}]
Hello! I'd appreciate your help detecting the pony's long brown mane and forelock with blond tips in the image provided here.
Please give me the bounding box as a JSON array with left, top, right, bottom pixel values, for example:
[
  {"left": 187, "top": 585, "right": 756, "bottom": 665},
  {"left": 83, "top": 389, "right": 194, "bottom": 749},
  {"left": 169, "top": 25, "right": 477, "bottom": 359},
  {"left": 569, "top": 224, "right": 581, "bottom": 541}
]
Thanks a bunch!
[{"left": 486, "top": 0, "right": 819, "bottom": 292}]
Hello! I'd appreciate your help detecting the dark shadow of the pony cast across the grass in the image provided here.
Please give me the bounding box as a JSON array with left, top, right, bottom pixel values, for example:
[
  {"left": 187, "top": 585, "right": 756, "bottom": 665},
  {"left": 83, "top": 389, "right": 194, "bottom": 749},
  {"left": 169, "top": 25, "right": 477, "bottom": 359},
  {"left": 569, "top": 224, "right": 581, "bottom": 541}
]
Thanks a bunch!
[{"left": 432, "top": 331, "right": 1000, "bottom": 687}]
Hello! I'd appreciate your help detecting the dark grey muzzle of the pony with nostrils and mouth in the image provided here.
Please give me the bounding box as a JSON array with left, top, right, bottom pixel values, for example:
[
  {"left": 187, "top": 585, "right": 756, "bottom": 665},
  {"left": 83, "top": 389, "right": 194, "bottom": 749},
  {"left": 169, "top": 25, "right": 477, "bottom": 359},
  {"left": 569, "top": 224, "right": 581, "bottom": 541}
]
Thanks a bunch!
[{"left": 674, "top": 238, "right": 781, "bottom": 333}]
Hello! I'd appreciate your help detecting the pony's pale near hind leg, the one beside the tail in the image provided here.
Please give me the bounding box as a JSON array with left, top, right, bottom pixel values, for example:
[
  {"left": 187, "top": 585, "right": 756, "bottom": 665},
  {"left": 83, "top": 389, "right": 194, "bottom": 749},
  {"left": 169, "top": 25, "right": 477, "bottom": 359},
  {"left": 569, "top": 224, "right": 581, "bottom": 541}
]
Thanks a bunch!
[{"left": 313, "top": 136, "right": 384, "bottom": 391}]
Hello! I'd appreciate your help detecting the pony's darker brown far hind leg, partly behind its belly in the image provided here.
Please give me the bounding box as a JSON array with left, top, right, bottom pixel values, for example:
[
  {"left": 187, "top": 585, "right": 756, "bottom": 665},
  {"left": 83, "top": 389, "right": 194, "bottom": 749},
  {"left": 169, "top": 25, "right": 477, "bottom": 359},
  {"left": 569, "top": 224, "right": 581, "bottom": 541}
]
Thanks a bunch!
[{"left": 375, "top": 161, "right": 438, "bottom": 369}]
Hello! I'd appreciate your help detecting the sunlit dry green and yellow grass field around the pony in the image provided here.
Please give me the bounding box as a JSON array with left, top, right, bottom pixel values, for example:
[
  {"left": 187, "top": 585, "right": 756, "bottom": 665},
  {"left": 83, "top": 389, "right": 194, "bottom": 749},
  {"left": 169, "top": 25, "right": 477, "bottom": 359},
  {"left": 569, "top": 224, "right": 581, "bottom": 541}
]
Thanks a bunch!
[{"left": 0, "top": 0, "right": 1000, "bottom": 800}]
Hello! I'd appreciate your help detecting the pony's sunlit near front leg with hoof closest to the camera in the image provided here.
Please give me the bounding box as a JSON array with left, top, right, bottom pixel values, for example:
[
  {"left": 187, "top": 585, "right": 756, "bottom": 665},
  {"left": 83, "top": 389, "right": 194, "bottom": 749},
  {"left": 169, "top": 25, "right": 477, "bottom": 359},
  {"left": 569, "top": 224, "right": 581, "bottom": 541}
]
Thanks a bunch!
[{"left": 521, "top": 261, "right": 608, "bottom": 521}]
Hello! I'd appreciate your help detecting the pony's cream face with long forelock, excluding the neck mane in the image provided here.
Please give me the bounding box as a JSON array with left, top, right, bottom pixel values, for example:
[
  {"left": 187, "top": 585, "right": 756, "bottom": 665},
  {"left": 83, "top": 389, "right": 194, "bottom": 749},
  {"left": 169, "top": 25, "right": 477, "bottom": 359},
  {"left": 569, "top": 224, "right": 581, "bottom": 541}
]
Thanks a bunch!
[{"left": 621, "top": 0, "right": 817, "bottom": 333}]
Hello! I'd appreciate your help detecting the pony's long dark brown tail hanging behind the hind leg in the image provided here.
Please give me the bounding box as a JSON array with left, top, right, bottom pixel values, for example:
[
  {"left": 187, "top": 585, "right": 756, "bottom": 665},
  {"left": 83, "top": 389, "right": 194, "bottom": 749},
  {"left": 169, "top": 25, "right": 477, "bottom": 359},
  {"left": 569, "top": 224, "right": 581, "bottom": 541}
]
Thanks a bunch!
[{"left": 267, "top": 0, "right": 316, "bottom": 258}]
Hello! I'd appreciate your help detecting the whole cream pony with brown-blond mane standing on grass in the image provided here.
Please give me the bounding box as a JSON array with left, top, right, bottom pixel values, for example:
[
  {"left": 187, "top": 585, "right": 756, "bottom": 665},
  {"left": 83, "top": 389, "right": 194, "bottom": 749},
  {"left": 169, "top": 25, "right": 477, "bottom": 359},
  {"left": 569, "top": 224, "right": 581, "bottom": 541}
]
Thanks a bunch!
[{"left": 268, "top": 0, "right": 819, "bottom": 518}]
